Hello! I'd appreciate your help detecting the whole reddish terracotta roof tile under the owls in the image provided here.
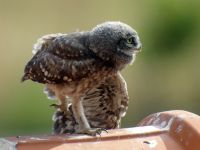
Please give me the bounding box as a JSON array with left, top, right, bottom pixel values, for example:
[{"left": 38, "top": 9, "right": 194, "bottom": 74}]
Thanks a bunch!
[{"left": 0, "top": 110, "right": 200, "bottom": 150}]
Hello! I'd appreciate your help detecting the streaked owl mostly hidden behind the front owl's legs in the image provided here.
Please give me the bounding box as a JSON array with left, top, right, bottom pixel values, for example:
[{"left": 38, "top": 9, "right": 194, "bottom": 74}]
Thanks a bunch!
[{"left": 53, "top": 74, "right": 129, "bottom": 134}]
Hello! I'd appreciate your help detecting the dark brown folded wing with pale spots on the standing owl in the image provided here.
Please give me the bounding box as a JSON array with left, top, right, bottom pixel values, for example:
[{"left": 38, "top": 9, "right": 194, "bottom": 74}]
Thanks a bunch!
[{"left": 22, "top": 32, "right": 95, "bottom": 83}]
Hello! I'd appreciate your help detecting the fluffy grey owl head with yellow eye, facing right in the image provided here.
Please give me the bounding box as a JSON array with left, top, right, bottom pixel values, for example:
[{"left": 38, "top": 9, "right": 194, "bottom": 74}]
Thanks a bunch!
[{"left": 89, "top": 22, "right": 141, "bottom": 67}]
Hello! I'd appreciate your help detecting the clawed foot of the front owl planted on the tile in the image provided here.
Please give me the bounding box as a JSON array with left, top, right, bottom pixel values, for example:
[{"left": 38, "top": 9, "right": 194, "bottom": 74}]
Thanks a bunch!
[{"left": 75, "top": 128, "right": 108, "bottom": 136}]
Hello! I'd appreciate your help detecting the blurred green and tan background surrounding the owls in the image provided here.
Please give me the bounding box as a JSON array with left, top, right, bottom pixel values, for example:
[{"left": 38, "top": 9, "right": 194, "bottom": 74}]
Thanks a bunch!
[{"left": 0, "top": 0, "right": 200, "bottom": 136}]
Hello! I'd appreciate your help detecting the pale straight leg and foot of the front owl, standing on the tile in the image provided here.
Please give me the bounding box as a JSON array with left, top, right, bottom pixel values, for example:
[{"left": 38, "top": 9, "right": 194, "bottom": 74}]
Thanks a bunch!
[{"left": 72, "top": 97, "right": 105, "bottom": 136}]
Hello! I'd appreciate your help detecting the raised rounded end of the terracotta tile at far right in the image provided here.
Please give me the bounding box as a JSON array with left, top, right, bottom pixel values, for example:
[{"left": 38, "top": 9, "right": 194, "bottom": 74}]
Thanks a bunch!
[{"left": 139, "top": 110, "right": 200, "bottom": 150}]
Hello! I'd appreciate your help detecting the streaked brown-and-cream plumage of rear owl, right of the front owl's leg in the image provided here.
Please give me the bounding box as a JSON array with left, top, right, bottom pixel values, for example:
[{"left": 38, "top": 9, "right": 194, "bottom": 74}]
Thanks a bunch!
[{"left": 83, "top": 73, "right": 128, "bottom": 129}]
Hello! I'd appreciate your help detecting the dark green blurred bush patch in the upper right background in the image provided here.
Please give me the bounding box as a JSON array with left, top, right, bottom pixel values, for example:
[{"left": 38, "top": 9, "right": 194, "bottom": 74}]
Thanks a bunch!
[{"left": 147, "top": 1, "right": 199, "bottom": 59}]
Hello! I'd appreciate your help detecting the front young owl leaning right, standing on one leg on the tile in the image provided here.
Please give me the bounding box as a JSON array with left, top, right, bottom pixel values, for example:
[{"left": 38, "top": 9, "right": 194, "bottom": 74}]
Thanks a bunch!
[{"left": 22, "top": 22, "right": 141, "bottom": 135}]
